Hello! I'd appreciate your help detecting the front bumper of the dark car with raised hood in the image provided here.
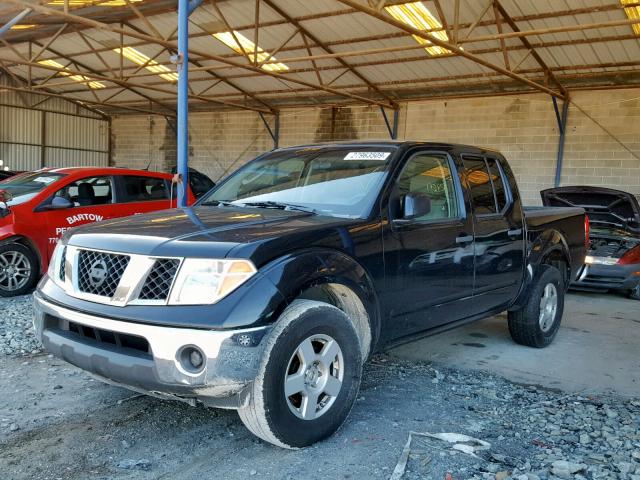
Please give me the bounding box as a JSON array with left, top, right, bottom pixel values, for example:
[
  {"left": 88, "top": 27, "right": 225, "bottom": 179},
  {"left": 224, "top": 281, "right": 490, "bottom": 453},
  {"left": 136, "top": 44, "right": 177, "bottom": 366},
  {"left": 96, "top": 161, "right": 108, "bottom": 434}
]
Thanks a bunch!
[{"left": 571, "top": 264, "right": 640, "bottom": 290}]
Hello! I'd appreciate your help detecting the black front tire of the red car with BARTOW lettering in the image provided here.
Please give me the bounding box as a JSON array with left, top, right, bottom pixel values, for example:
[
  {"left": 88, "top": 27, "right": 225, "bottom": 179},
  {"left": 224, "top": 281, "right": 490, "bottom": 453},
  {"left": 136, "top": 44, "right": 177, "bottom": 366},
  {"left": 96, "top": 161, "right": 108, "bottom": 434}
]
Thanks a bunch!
[{"left": 0, "top": 243, "right": 40, "bottom": 297}]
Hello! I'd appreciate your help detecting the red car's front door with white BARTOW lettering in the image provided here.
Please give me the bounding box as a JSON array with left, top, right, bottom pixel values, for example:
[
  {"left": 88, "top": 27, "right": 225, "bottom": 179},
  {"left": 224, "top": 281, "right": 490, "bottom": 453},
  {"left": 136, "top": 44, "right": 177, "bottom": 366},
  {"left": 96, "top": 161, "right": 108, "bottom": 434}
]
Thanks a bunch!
[{"left": 38, "top": 176, "right": 121, "bottom": 256}]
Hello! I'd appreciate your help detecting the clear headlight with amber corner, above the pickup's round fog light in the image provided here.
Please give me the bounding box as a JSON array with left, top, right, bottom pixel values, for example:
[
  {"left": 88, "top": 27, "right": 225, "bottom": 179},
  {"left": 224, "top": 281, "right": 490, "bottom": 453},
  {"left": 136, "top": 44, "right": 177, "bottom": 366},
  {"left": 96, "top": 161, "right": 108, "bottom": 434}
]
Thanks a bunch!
[{"left": 169, "top": 258, "right": 257, "bottom": 305}]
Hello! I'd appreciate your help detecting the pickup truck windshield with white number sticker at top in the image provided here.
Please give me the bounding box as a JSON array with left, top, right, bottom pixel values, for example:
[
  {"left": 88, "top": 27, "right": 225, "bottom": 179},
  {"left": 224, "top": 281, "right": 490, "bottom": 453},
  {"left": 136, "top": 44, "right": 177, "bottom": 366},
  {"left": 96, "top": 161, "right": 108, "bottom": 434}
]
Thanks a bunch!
[{"left": 200, "top": 147, "right": 394, "bottom": 218}]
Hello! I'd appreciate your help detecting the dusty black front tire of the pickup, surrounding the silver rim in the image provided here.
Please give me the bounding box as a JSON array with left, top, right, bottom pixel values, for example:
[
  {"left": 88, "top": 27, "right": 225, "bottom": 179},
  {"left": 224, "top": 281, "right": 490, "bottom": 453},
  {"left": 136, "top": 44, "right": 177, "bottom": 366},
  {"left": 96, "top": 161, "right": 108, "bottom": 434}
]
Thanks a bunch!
[{"left": 238, "top": 300, "right": 362, "bottom": 448}]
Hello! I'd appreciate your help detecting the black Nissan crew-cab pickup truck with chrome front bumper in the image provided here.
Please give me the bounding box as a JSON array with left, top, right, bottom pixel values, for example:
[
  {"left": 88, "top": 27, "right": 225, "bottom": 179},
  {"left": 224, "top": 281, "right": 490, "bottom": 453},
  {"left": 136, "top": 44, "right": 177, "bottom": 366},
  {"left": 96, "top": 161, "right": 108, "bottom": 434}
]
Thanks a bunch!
[{"left": 34, "top": 142, "right": 585, "bottom": 448}]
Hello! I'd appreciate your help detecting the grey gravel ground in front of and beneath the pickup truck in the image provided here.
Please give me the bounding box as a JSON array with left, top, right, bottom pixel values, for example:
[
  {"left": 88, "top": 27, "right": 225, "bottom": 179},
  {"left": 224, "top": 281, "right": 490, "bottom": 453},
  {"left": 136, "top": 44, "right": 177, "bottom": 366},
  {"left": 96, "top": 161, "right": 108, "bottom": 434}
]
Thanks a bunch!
[{"left": 0, "top": 297, "right": 640, "bottom": 480}]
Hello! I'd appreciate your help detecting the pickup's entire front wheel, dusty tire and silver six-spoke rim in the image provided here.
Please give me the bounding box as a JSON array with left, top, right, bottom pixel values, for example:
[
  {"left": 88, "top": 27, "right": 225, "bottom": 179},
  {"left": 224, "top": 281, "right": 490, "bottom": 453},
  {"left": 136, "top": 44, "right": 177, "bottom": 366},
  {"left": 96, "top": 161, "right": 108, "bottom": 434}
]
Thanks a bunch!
[{"left": 238, "top": 300, "right": 362, "bottom": 448}]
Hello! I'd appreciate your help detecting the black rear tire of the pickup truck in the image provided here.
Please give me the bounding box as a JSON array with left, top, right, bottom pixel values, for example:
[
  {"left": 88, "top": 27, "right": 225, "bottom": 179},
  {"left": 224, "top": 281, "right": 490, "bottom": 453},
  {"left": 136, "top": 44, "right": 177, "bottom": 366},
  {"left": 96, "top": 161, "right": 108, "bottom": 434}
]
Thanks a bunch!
[{"left": 508, "top": 265, "right": 565, "bottom": 348}]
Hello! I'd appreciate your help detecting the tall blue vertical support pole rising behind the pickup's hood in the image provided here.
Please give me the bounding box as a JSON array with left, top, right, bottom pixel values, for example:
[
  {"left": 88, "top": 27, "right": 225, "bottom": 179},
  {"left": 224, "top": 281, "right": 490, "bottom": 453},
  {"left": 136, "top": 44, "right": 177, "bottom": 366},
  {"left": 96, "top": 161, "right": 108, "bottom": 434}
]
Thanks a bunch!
[{"left": 177, "top": 0, "right": 189, "bottom": 207}]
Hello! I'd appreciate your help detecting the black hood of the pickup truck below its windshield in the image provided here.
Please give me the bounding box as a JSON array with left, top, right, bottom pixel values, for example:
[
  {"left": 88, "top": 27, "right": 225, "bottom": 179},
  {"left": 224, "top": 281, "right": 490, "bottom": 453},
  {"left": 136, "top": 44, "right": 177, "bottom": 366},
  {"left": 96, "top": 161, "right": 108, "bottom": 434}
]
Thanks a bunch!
[{"left": 63, "top": 206, "right": 354, "bottom": 261}]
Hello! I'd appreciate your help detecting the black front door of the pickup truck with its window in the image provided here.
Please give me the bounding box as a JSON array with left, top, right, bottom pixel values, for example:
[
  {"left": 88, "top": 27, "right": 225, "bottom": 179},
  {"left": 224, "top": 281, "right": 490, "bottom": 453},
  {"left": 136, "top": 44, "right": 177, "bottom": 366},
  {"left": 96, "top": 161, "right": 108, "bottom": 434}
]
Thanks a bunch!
[{"left": 384, "top": 152, "right": 473, "bottom": 337}]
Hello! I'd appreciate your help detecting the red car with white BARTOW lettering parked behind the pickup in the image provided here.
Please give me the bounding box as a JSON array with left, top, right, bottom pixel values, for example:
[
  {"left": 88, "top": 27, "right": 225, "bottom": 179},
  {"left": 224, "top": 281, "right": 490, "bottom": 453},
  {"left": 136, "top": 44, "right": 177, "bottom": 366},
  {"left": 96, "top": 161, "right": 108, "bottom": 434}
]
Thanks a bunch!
[{"left": 0, "top": 167, "right": 195, "bottom": 297}]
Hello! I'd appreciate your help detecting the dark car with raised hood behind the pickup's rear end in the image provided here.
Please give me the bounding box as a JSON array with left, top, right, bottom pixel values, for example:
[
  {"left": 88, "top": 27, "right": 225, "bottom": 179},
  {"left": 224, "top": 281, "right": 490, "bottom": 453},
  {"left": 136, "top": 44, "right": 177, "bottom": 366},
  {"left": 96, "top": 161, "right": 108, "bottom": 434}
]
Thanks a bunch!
[{"left": 541, "top": 186, "right": 640, "bottom": 300}]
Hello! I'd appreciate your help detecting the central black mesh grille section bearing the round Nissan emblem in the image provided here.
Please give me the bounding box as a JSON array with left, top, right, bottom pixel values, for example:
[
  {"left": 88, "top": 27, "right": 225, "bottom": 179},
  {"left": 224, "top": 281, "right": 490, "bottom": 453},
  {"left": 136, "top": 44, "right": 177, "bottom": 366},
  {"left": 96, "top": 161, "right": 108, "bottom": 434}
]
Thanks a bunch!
[{"left": 77, "top": 250, "right": 130, "bottom": 298}]
